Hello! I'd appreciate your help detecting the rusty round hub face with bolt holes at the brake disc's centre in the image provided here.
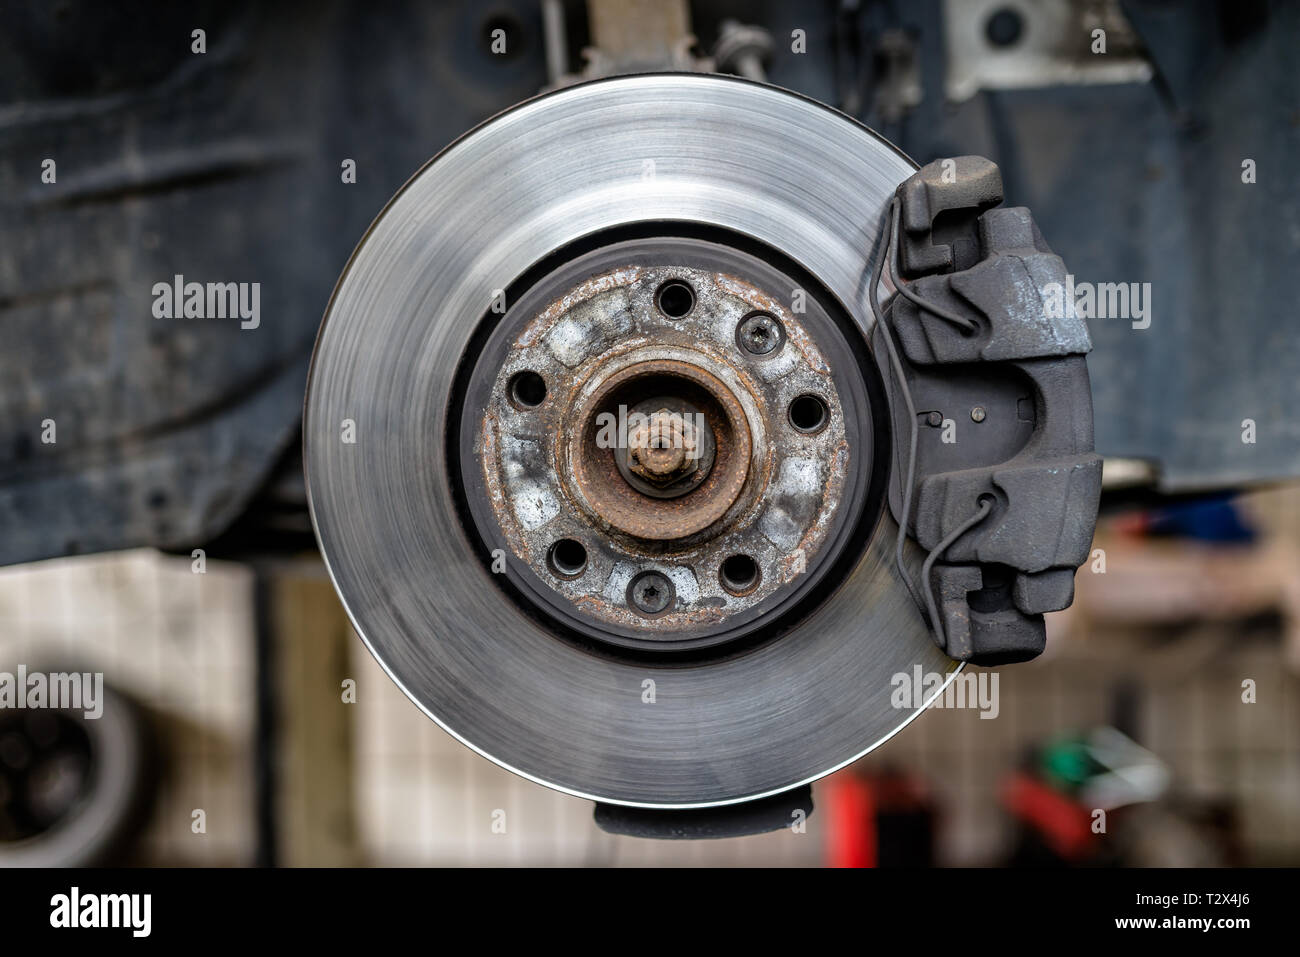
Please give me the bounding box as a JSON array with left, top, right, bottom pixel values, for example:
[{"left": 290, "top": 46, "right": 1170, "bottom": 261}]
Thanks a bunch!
[{"left": 463, "top": 239, "right": 872, "bottom": 650}]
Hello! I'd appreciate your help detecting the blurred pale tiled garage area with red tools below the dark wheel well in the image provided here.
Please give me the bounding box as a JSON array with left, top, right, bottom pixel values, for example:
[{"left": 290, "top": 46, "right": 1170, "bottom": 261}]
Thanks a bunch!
[{"left": 0, "top": 485, "right": 1300, "bottom": 866}]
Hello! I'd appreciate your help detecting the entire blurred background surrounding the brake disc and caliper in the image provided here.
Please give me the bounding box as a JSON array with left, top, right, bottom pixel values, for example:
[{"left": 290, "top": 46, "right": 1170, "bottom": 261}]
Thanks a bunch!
[{"left": 0, "top": 0, "right": 1300, "bottom": 866}]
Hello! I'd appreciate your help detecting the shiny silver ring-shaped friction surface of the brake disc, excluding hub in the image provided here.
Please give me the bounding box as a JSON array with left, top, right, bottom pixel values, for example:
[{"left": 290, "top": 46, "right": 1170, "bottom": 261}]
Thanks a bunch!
[{"left": 303, "top": 74, "right": 956, "bottom": 807}]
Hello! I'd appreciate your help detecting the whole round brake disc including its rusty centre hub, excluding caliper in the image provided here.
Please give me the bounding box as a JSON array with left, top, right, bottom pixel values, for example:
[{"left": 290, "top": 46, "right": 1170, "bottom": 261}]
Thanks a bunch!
[{"left": 304, "top": 74, "right": 956, "bottom": 807}]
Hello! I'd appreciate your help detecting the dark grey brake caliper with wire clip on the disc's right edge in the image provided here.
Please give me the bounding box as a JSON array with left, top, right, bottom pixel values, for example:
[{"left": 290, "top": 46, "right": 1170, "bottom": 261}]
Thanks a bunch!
[{"left": 872, "top": 156, "right": 1101, "bottom": 664}]
